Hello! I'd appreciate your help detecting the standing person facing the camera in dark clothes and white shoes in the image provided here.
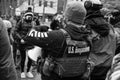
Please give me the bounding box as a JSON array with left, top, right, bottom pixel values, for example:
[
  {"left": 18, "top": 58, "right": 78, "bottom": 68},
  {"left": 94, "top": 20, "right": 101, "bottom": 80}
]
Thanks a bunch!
[{"left": 14, "top": 9, "right": 35, "bottom": 78}]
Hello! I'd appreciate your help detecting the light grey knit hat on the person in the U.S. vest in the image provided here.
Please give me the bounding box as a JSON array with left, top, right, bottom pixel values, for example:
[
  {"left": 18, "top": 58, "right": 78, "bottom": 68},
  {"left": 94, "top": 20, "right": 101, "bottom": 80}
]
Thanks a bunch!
[{"left": 63, "top": 1, "right": 86, "bottom": 24}]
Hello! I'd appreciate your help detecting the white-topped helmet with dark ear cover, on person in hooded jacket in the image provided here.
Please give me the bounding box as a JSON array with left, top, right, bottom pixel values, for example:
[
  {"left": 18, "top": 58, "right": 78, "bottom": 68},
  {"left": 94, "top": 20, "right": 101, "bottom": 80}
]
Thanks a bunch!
[{"left": 84, "top": 0, "right": 103, "bottom": 10}]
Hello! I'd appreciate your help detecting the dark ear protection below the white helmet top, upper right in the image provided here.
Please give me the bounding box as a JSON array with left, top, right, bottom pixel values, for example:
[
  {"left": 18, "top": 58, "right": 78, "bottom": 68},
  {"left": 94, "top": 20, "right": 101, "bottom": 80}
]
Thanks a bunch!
[{"left": 84, "top": 0, "right": 103, "bottom": 10}]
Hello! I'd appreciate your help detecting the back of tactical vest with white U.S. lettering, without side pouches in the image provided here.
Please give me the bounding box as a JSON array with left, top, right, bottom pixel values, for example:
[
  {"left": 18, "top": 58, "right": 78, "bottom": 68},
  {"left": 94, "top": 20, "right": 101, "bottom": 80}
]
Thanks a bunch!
[{"left": 55, "top": 37, "right": 90, "bottom": 77}]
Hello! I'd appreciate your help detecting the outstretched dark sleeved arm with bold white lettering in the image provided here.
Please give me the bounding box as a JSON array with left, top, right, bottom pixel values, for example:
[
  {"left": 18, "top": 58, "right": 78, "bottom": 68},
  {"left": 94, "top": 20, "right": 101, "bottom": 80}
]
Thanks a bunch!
[{"left": 24, "top": 29, "right": 65, "bottom": 48}]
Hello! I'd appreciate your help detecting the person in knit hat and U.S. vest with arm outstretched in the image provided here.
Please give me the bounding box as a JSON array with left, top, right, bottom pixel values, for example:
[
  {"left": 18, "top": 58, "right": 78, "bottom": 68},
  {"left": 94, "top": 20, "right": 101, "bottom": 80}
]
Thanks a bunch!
[{"left": 24, "top": 2, "right": 90, "bottom": 80}]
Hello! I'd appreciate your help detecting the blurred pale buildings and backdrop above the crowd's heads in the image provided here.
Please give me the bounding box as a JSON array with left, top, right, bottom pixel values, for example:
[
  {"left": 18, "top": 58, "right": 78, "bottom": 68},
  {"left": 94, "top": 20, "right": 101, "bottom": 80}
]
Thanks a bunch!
[{"left": 0, "top": 0, "right": 120, "bottom": 22}]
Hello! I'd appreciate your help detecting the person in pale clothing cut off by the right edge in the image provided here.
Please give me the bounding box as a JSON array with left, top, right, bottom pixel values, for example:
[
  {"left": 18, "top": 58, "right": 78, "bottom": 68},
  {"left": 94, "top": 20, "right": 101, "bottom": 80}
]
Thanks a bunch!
[{"left": 106, "top": 5, "right": 120, "bottom": 80}]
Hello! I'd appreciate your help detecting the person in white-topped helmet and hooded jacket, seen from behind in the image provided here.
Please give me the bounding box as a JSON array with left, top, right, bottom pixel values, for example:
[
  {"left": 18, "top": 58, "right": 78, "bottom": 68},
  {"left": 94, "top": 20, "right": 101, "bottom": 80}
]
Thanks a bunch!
[{"left": 84, "top": 0, "right": 117, "bottom": 80}]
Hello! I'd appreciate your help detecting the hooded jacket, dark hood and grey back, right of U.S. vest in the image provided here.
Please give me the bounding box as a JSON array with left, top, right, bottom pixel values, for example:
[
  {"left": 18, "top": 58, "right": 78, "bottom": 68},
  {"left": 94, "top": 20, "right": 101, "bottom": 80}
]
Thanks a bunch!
[{"left": 85, "top": 11, "right": 116, "bottom": 66}]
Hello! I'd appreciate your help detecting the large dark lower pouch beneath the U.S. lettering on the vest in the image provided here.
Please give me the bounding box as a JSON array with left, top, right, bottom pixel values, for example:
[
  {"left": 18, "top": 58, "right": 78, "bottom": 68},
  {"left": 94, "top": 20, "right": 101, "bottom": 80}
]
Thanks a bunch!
[{"left": 55, "top": 57, "right": 87, "bottom": 77}]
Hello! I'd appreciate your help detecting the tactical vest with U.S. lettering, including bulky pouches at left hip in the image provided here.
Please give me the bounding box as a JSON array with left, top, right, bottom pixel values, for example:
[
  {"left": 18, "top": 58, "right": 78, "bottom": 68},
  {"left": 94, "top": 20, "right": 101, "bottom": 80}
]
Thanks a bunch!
[{"left": 38, "top": 29, "right": 94, "bottom": 77}]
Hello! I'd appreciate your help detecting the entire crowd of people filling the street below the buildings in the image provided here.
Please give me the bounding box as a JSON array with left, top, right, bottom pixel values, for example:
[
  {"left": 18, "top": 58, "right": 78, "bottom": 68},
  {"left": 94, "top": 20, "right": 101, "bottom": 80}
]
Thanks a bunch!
[{"left": 0, "top": 0, "right": 120, "bottom": 80}]
